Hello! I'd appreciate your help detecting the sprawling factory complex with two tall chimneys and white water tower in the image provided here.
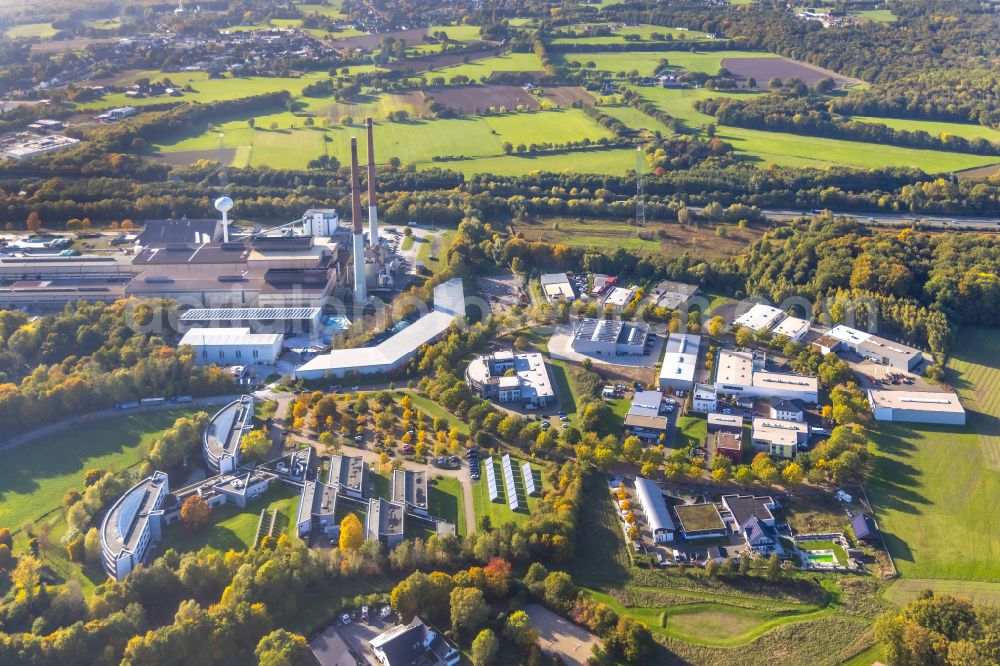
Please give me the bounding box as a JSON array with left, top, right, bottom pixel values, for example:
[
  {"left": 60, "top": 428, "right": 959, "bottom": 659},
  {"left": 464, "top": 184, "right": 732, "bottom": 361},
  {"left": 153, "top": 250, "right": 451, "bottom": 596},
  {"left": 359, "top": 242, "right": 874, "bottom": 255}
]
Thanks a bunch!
[{"left": 0, "top": 119, "right": 401, "bottom": 312}]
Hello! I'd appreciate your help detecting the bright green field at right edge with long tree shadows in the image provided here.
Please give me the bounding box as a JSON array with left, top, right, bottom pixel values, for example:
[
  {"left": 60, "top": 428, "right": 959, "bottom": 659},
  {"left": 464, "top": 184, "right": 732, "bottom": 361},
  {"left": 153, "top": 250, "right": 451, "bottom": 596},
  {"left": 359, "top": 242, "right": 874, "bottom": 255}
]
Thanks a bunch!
[{"left": 867, "top": 328, "right": 1000, "bottom": 581}]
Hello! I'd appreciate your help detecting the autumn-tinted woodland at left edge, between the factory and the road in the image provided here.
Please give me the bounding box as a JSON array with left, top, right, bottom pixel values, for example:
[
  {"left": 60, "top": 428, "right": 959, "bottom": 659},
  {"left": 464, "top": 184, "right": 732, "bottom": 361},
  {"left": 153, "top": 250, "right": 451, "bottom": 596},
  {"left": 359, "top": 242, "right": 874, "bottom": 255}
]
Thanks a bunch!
[{"left": 0, "top": 299, "right": 236, "bottom": 436}]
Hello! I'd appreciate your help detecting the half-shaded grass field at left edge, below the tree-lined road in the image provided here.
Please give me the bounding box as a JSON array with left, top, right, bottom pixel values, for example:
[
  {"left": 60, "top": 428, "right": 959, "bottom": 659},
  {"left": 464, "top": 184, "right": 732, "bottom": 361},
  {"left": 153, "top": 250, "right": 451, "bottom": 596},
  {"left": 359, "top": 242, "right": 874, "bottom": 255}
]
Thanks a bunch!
[{"left": 0, "top": 409, "right": 204, "bottom": 529}]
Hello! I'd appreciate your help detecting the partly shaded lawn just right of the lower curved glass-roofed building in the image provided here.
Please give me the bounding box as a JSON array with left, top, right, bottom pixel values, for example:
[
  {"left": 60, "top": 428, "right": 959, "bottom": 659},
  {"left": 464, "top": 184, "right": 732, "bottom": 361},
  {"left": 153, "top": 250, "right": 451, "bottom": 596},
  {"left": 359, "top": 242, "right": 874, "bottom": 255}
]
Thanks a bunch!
[{"left": 159, "top": 484, "right": 299, "bottom": 553}]
